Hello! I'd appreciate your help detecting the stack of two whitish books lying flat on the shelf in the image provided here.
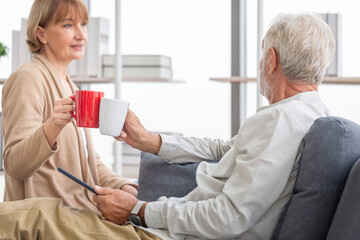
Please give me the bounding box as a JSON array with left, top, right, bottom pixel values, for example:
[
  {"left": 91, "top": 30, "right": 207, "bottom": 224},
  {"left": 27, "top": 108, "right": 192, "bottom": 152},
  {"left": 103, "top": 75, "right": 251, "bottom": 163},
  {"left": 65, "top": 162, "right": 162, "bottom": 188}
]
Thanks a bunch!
[{"left": 103, "top": 55, "right": 172, "bottom": 81}]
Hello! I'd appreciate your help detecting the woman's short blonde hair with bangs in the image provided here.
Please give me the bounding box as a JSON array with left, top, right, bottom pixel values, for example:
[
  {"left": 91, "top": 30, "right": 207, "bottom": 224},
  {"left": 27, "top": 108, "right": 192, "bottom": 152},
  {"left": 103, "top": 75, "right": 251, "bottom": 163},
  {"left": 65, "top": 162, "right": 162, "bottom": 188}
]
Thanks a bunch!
[{"left": 26, "top": 0, "right": 89, "bottom": 53}]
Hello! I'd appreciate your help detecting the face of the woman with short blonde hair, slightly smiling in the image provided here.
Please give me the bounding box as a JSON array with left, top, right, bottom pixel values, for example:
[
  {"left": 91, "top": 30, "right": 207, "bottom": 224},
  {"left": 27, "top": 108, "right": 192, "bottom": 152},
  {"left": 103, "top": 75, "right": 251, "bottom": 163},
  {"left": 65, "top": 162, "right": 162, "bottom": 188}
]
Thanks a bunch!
[{"left": 42, "top": 8, "right": 88, "bottom": 63}]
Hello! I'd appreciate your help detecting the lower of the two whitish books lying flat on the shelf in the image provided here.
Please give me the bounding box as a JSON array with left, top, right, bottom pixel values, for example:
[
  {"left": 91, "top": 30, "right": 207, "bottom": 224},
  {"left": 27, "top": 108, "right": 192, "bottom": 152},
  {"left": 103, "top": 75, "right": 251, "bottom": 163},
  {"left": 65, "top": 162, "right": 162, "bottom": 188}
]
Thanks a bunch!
[{"left": 103, "top": 66, "right": 172, "bottom": 79}]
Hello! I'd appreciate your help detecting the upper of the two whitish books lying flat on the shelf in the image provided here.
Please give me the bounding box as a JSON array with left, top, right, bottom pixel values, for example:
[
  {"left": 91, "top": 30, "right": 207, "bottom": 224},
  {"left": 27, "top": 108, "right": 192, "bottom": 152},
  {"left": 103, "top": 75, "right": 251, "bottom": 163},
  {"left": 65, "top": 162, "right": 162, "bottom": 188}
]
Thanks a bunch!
[{"left": 103, "top": 54, "right": 171, "bottom": 68}]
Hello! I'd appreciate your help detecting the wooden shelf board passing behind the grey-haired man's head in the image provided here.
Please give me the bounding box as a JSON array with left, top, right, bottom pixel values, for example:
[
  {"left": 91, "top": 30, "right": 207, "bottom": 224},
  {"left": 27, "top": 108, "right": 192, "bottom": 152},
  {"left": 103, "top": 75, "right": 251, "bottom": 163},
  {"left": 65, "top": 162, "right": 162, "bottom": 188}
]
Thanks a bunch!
[{"left": 210, "top": 77, "right": 360, "bottom": 84}]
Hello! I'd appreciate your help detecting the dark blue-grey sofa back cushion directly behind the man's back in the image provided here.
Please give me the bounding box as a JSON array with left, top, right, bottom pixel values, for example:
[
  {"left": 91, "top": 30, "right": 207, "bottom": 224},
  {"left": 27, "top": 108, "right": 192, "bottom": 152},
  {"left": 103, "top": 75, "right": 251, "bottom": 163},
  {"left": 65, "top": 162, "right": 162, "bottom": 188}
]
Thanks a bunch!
[{"left": 272, "top": 117, "right": 360, "bottom": 240}]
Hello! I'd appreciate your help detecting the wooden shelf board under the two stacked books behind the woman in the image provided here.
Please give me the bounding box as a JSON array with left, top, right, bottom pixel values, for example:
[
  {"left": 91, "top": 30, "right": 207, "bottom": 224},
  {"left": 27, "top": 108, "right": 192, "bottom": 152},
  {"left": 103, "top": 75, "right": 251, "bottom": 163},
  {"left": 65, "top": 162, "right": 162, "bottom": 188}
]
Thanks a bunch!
[{"left": 0, "top": 77, "right": 185, "bottom": 84}]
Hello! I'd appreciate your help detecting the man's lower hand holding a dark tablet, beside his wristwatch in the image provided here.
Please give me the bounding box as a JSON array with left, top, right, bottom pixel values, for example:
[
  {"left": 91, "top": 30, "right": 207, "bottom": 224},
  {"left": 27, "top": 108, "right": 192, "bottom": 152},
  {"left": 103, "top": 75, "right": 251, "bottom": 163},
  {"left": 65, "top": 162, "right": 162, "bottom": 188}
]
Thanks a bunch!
[{"left": 93, "top": 186, "right": 139, "bottom": 225}]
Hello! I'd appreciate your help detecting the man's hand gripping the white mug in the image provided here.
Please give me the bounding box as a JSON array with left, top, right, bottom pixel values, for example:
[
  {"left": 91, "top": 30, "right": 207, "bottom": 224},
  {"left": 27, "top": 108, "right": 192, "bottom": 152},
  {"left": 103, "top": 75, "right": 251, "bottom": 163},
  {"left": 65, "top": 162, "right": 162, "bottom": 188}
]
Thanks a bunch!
[{"left": 115, "top": 109, "right": 161, "bottom": 154}]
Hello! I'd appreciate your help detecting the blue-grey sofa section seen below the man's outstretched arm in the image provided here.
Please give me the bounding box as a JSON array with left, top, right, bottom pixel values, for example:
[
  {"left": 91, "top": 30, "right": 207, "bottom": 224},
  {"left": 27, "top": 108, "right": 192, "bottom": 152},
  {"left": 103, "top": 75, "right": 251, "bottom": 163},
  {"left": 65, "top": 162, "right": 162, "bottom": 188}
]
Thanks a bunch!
[{"left": 138, "top": 152, "right": 199, "bottom": 201}]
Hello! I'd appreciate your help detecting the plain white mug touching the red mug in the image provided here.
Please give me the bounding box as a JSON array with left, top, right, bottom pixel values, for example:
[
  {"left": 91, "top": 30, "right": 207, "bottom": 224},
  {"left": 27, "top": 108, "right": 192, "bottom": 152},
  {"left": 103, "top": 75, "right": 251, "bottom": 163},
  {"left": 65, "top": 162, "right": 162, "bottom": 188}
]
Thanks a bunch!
[{"left": 99, "top": 98, "right": 129, "bottom": 137}]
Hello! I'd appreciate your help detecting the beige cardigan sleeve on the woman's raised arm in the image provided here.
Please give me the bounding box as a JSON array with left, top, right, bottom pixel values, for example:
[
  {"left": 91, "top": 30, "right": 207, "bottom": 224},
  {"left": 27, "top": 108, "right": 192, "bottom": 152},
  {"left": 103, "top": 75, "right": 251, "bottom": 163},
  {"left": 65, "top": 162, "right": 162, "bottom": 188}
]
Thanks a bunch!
[{"left": 2, "top": 70, "right": 71, "bottom": 181}]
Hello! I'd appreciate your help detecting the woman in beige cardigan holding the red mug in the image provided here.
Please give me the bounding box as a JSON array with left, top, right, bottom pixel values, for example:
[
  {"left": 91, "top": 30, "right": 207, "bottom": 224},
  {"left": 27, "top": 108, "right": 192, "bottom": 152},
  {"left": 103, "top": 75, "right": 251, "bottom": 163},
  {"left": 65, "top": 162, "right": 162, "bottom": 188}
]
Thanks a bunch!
[{"left": 2, "top": 0, "right": 137, "bottom": 213}]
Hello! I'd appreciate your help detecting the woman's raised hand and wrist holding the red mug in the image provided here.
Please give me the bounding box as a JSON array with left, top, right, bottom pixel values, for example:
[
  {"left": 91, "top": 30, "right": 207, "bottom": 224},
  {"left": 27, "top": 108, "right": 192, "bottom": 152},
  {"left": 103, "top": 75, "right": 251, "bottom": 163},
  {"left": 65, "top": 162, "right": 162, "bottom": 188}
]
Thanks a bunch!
[{"left": 43, "top": 98, "right": 74, "bottom": 148}]
